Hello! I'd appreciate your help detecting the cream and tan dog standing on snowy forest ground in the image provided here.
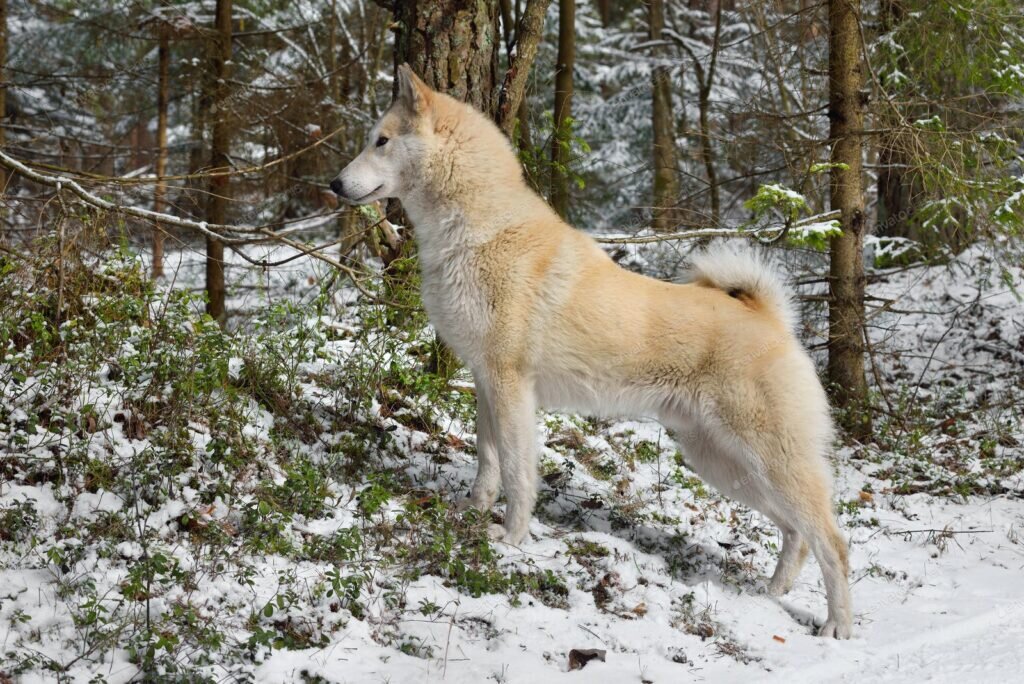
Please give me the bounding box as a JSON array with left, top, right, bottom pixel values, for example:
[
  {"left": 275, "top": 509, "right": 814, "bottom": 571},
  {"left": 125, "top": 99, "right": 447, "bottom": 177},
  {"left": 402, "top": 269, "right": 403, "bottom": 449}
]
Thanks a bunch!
[{"left": 331, "top": 65, "right": 852, "bottom": 639}]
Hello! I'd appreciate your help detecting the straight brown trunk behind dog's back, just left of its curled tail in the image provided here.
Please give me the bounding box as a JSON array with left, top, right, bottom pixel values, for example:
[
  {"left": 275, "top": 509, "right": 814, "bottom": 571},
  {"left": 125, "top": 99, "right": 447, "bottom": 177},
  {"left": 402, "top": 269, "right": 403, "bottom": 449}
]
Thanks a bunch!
[{"left": 648, "top": 0, "right": 679, "bottom": 232}]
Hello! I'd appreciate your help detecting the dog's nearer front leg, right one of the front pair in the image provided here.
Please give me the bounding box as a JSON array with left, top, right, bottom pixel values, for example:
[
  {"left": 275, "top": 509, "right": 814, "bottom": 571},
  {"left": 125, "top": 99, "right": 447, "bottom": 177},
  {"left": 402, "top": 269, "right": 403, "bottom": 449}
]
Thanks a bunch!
[{"left": 487, "top": 373, "right": 538, "bottom": 544}]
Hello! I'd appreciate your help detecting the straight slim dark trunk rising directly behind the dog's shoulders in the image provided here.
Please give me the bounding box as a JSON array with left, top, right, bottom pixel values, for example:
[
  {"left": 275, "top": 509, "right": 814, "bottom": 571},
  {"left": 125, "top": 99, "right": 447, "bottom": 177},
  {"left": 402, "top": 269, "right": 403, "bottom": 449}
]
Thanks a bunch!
[{"left": 551, "top": 0, "right": 575, "bottom": 218}]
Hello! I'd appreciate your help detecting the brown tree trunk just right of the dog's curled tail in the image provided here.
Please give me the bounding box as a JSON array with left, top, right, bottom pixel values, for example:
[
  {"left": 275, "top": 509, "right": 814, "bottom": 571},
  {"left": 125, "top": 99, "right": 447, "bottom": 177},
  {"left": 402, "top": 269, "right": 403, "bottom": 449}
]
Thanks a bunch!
[{"left": 828, "top": 0, "right": 870, "bottom": 438}]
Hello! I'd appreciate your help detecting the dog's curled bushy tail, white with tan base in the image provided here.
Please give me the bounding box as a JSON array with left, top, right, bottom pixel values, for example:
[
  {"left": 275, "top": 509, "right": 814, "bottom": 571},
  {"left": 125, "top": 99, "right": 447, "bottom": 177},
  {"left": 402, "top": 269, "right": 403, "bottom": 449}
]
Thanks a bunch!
[{"left": 688, "top": 242, "right": 799, "bottom": 332}]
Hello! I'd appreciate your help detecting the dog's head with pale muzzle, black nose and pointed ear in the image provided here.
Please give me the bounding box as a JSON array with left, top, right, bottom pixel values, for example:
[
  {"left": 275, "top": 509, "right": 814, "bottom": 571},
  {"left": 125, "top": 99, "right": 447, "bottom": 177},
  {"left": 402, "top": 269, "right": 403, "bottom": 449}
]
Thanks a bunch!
[{"left": 331, "top": 65, "right": 437, "bottom": 205}]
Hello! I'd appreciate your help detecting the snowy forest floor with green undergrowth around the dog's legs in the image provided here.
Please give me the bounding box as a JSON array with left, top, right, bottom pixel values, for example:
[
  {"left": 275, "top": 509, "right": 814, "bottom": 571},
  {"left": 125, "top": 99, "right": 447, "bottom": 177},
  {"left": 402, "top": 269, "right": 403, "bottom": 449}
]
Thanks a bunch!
[{"left": 0, "top": 233, "right": 1024, "bottom": 683}]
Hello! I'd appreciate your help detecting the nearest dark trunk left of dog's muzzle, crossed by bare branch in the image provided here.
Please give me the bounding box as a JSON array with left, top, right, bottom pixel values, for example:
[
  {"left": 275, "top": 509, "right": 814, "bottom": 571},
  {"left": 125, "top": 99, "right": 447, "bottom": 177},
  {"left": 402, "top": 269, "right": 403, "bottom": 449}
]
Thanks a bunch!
[{"left": 206, "top": 0, "right": 231, "bottom": 326}]
